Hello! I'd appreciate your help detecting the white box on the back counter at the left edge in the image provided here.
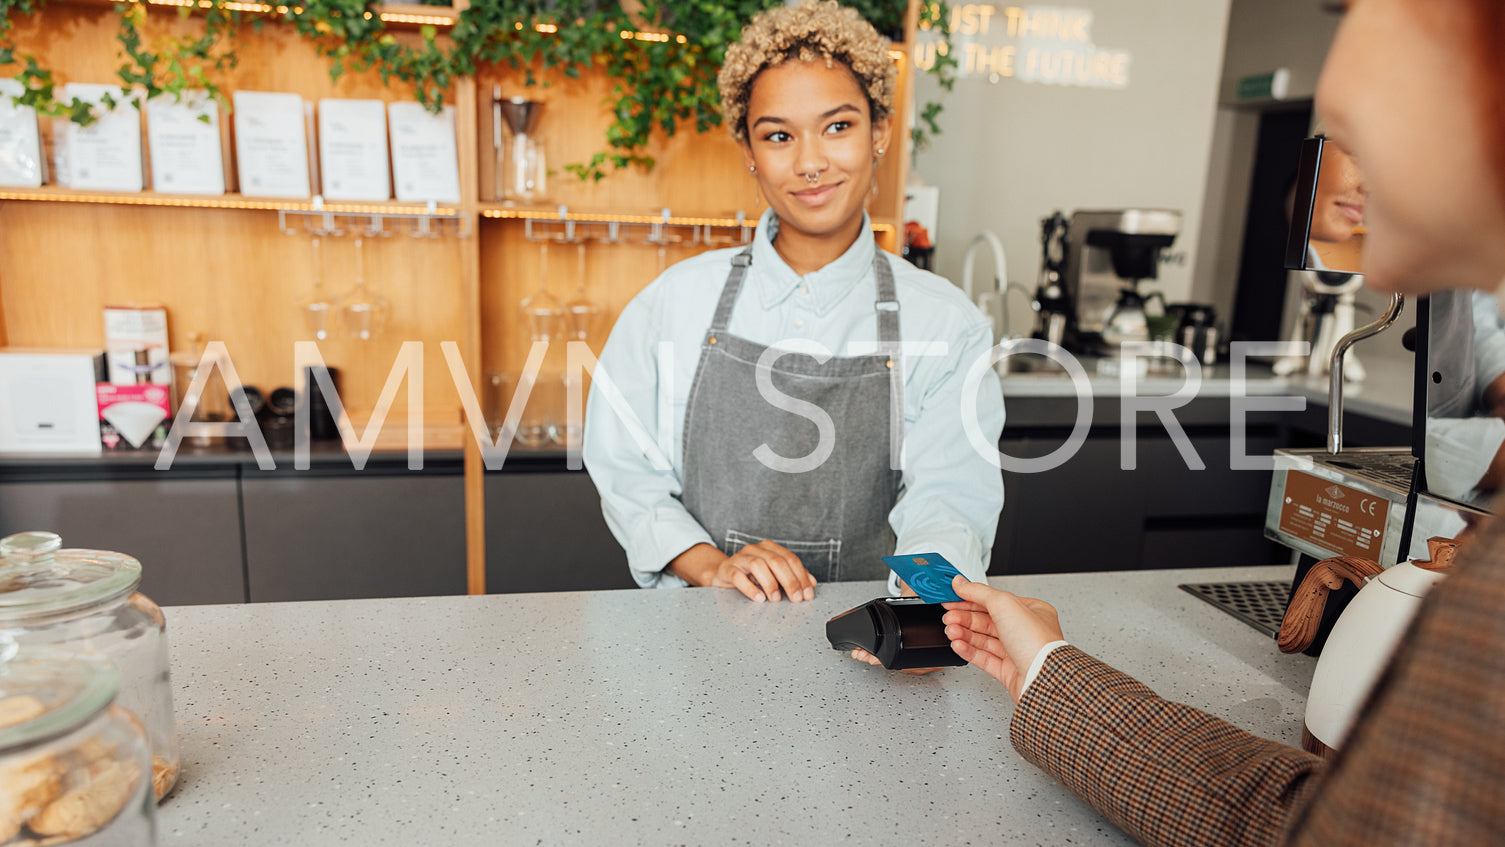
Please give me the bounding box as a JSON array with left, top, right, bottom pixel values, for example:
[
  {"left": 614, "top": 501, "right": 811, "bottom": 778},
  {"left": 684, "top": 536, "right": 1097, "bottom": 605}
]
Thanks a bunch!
[{"left": 0, "top": 348, "right": 104, "bottom": 453}]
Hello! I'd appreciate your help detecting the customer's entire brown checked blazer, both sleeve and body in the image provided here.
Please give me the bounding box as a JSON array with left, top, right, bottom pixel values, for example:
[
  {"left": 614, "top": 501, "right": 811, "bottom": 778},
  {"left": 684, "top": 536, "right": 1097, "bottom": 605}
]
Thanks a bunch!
[{"left": 1011, "top": 499, "right": 1505, "bottom": 847}]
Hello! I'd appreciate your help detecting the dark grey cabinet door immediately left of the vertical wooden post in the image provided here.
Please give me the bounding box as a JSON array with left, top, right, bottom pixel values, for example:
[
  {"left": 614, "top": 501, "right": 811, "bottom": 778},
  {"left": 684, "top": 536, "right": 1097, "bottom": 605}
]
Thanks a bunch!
[{"left": 241, "top": 463, "right": 465, "bottom": 602}]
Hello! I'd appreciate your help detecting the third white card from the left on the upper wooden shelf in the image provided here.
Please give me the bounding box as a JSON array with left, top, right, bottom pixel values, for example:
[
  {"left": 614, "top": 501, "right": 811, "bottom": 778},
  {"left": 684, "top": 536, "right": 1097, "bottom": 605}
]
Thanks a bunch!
[{"left": 146, "top": 90, "right": 224, "bottom": 194}]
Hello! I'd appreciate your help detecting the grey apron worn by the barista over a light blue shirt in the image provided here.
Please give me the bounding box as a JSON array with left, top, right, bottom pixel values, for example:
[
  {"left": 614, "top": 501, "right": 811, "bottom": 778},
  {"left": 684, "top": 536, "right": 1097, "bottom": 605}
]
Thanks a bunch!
[{"left": 680, "top": 250, "right": 905, "bottom": 582}]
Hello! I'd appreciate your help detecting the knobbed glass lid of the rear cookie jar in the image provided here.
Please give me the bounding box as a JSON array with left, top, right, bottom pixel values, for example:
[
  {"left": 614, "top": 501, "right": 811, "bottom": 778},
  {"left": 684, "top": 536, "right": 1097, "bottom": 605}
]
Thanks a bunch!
[{"left": 0, "top": 533, "right": 141, "bottom": 624}]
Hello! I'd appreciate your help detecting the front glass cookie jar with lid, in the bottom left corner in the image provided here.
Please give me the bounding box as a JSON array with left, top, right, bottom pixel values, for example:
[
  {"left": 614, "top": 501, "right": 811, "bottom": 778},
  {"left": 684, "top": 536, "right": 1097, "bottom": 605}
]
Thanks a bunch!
[{"left": 0, "top": 641, "right": 157, "bottom": 847}]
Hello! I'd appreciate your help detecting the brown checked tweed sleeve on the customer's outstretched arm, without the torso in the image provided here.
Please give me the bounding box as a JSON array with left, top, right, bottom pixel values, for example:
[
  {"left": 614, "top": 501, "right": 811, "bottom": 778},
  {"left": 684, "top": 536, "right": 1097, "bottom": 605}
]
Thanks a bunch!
[{"left": 1010, "top": 645, "right": 1324, "bottom": 845}]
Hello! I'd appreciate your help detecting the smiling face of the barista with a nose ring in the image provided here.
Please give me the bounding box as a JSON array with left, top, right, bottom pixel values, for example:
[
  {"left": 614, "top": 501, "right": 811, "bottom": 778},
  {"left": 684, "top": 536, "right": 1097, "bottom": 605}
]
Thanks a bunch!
[{"left": 743, "top": 60, "right": 889, "bottom": 245}]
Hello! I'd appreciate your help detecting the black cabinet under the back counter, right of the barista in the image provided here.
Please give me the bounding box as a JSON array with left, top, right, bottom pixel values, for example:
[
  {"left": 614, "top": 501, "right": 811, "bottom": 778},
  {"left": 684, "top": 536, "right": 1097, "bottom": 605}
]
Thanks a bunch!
[{"left": 989, "top": 399, "right": 1290, "bottom": 575}]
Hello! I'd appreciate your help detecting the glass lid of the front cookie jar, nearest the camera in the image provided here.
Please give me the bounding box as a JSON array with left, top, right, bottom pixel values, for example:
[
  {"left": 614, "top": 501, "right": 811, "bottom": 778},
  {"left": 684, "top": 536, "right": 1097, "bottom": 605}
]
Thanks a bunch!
[{"left": 0, "top": 641, "right": 120, "bottom": 752}]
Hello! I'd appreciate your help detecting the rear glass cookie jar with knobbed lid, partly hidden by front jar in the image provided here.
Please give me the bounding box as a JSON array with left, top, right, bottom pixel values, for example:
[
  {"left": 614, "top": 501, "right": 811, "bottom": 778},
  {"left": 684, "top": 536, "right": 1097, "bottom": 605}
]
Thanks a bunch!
[{"left": 0, "top": 533, "right": 178, "bottom": 806}]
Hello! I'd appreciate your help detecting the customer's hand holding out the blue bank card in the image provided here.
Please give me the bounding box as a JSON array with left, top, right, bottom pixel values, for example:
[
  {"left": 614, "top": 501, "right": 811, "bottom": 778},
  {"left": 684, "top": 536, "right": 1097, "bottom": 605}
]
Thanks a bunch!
[{"left": 941, "top": 576, "right": 1066, "bottom": 703}]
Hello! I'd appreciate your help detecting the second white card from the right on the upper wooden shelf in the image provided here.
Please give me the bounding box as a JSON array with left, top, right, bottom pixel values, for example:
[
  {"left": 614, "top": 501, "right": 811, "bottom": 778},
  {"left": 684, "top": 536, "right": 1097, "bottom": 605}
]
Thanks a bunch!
[{"left": 319, "top": 99, "right": 391, "bottom": 200}]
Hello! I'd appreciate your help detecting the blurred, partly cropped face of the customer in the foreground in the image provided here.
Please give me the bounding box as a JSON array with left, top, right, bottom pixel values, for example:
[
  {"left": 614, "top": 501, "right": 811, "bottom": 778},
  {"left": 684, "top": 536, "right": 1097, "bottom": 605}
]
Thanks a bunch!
[{"left": 1317, "top": 0, "right": 1505, "bottom": 293}]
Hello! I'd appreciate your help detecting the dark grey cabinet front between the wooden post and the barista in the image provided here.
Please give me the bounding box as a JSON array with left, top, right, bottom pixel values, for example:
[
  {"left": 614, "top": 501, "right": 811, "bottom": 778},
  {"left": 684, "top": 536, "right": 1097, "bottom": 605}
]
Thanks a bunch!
[{"left": 486, "top": 469, "right": 637, "bottom": 594}]
